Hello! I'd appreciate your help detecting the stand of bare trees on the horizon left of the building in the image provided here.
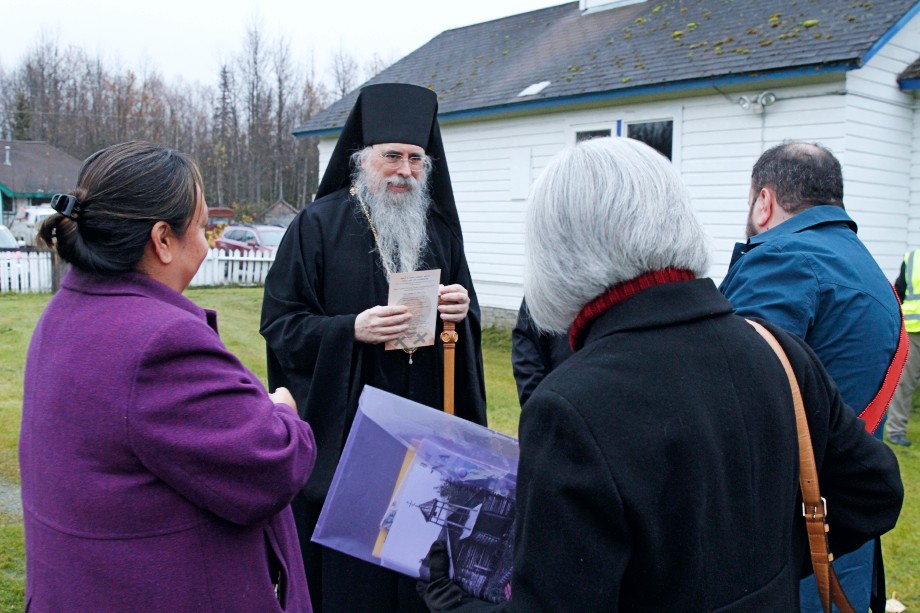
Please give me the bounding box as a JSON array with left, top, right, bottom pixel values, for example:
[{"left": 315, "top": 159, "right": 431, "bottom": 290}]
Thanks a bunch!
[{"left": 0, "top": 24, "right": 344, "bottom": 215}]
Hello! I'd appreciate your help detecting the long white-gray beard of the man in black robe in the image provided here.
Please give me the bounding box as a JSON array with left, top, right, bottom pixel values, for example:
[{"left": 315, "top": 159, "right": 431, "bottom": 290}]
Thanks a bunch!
[{"left": 354, "top": 166, "right": 431, "bottom": 272}]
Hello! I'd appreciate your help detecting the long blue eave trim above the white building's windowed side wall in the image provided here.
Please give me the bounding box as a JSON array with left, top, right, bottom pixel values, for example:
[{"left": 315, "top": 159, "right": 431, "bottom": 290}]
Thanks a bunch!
[{"left": 293, "top": 61, "right": 859, "bottom": 138}]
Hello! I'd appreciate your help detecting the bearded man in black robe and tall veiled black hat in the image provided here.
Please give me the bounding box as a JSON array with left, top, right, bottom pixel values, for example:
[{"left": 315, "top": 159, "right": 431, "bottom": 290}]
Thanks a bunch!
[{"left": 260, "top": 83, "right": 486, "bottom": 613}]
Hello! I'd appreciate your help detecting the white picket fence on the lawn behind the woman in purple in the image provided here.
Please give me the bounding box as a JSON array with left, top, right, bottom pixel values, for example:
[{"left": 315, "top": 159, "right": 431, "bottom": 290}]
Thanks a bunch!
[{"left": 0, "top": 249, "right": 275, "bottom": 292}]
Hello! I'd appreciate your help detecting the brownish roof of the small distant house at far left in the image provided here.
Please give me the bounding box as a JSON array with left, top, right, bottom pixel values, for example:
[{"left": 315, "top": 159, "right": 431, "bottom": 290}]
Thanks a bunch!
[{"left": 0, "top": 140, "right": 82, "bottom": 197}]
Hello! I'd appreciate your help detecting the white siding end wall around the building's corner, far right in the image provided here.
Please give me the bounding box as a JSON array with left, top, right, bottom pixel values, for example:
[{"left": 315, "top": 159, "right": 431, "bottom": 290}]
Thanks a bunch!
[{"left": 841, "top": 11, "right": 920, "bottom": 279}]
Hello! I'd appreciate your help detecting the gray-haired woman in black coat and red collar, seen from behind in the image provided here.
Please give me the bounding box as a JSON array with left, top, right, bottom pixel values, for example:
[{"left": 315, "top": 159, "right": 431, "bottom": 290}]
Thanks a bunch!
[{"left": 420, "top": 138, "right": 903, "bottom": 612}]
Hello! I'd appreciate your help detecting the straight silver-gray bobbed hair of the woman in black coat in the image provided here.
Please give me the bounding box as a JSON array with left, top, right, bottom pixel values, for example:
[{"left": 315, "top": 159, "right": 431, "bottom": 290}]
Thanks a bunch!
[{"left": 524, "top": 138, "right": 709, "bottom": 332}]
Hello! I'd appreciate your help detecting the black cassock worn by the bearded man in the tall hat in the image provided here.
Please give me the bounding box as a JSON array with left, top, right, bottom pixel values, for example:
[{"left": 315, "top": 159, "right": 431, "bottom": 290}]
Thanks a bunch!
[{"left": 260, "top": 189, "right": 486, "bottom": 602}]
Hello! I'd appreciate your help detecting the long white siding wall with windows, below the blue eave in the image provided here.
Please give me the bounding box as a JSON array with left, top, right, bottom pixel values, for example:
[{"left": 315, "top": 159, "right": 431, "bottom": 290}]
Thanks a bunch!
[{"left": 320, "top": 89, "right": 845, "bottom": 310}]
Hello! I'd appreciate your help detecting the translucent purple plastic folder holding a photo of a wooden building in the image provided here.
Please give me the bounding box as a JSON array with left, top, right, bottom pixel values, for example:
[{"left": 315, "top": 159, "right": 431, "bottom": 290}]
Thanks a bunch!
[{"left": 313, "top": 387, "right": 518, "bottom": 602}]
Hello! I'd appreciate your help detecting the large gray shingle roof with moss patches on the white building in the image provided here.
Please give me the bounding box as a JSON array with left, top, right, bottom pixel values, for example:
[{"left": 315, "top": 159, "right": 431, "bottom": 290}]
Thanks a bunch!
[{"left": 295, "top": 0, "right": 920, "bottom": 136}]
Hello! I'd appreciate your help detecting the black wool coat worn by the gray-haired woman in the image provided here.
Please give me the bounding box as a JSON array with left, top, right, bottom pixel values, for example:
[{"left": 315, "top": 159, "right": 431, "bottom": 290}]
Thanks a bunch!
[{"left": 452, "top": 279, "right": 904, "bottom": 612}]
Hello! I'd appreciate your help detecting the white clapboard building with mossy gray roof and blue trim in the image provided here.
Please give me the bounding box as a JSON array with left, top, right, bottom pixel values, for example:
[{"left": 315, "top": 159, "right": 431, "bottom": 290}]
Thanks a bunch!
[{"left": 295, "top": 0, "right": 920, "bottom": 321}]
